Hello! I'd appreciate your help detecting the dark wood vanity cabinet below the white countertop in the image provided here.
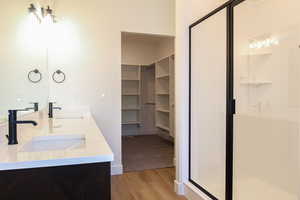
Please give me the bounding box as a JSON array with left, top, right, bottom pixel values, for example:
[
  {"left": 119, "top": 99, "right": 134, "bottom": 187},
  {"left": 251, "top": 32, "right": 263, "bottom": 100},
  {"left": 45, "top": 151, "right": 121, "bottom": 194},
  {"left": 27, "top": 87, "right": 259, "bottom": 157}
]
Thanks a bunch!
[{"left": 0, "top": 162, "right": 111, "bottom": 200}]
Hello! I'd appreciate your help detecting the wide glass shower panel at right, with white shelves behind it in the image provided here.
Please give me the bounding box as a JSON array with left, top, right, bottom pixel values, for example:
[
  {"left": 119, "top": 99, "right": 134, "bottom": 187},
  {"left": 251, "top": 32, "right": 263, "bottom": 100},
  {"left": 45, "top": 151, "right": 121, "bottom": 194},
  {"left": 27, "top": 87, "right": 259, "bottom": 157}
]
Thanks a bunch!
[{"left": 234, "top": 0, "right": 300, "bottom": 200}]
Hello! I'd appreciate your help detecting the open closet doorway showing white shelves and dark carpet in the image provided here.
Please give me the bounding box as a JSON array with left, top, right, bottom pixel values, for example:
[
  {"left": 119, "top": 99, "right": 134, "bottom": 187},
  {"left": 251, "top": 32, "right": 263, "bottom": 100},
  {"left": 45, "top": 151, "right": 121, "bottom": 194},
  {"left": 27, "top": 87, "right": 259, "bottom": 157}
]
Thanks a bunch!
[{"left": 121, "top": 32, "right": 175, "bottom": 172}]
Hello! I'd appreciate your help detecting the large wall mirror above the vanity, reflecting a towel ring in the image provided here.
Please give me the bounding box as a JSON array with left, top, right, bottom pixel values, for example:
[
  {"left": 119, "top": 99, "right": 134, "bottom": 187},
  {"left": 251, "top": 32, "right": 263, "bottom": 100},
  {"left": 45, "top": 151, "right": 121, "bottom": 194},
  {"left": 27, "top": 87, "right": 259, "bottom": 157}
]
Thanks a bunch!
[{"left": 0, "top": 1, "right": 48, "bottom": 121}]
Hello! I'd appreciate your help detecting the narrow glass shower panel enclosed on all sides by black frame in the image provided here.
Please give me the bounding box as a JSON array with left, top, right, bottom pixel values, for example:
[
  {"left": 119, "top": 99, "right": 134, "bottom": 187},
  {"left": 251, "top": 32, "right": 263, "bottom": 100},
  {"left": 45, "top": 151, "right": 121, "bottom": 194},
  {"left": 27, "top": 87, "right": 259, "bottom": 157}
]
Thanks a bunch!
[{"left": 190, "top": 9, "right": 226, "bottom": 200}]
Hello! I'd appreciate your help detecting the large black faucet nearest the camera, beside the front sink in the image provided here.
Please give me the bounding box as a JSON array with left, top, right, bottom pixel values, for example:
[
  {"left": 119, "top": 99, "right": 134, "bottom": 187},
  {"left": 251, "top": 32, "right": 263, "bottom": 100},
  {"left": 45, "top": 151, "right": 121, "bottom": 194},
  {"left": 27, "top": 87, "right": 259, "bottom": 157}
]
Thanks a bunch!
[{"left": 6, "top": 109, "right": 37, "bottom": 145}]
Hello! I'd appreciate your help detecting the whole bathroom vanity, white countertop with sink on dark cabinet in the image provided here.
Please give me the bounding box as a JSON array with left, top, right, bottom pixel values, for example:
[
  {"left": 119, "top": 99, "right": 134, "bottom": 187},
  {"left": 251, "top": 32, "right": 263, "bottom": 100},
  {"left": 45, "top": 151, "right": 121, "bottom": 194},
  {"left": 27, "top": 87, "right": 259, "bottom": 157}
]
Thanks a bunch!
[{"left": 0, "top": 112, "right": 113, "bottom": 200}]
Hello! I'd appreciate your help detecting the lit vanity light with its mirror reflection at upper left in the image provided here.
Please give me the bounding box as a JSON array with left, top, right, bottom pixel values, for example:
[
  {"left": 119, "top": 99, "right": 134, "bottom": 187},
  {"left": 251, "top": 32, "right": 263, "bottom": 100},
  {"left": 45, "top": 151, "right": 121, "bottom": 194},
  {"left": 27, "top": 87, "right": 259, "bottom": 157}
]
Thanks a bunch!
[{"left": 28, "top": 4, "right": 57, "bottom": 24}]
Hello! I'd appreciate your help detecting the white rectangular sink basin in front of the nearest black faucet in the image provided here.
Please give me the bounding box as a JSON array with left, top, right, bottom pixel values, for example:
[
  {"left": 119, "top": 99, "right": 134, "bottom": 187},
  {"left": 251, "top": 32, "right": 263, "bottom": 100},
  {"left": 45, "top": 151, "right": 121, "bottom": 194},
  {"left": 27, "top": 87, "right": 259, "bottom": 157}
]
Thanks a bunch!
[{"left": 21, "top": 134, "right": 85, "bottom": 152}]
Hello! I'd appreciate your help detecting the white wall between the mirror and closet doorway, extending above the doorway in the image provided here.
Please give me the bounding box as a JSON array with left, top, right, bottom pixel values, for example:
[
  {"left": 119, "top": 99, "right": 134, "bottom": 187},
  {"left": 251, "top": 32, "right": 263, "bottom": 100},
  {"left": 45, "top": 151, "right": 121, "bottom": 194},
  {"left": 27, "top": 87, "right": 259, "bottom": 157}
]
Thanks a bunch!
[{"left": 49, "top": 0, "right": 175, "bottom": 173}]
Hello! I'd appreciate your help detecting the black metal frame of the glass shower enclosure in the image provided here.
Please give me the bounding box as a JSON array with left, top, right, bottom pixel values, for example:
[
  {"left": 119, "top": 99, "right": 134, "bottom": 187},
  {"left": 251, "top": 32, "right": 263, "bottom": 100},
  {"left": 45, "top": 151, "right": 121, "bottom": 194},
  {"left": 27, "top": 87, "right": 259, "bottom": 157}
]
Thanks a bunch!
[{"left": 188, "top": 0, "right": 246, "bottom": 200}]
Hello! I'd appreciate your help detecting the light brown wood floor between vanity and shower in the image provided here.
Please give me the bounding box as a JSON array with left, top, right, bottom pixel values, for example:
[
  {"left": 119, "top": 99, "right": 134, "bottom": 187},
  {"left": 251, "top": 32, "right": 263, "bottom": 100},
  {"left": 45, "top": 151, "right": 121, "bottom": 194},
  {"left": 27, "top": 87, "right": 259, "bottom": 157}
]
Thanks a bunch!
[{"left": 112, "top": 168, "right": 186, "bottom": 200}]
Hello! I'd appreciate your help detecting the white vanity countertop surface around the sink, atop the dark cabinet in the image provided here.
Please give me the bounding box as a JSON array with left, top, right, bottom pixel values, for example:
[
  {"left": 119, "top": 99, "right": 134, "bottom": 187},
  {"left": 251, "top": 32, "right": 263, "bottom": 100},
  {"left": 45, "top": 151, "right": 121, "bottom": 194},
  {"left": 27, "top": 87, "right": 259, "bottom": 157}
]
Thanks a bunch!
[{"left": 0, "top": 112, "right": 113, "bottom": 171}]
